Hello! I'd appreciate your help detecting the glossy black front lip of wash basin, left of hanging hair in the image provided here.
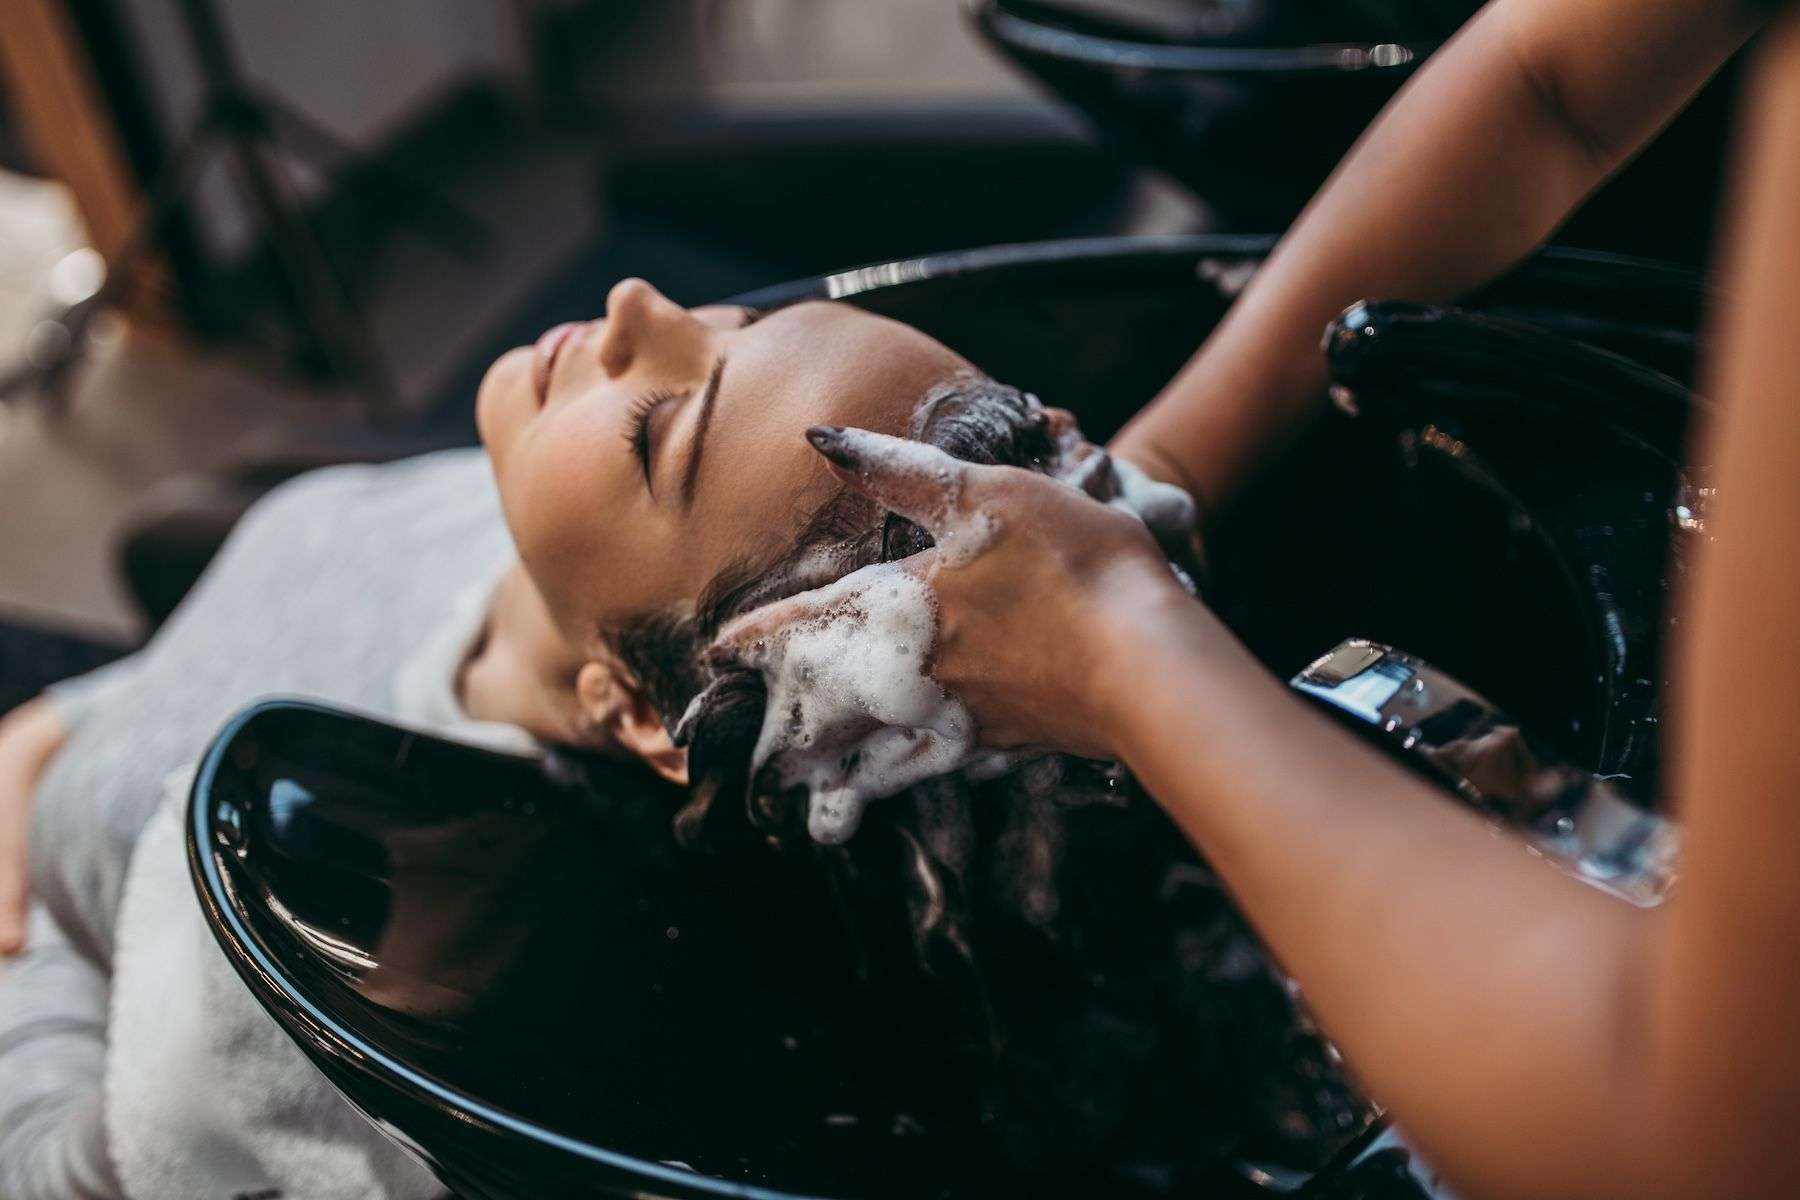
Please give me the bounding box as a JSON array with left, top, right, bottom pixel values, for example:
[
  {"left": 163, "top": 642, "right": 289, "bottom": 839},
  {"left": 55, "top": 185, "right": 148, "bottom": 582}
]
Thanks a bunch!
[{"left": 191, "top": 702, "right": 1051, "bottom": 1196}]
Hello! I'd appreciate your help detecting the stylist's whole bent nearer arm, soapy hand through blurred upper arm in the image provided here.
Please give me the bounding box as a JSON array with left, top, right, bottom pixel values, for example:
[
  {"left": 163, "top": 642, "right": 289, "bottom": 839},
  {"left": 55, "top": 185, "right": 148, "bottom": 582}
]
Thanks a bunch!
[{"left": 815, "top": 37, "right": 1800, "bottom": 1165}]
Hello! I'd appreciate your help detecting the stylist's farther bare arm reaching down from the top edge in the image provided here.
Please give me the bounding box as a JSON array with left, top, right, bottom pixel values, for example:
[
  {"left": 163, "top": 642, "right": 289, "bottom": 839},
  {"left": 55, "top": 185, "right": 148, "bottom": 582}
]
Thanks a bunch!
[{"left": 1114, "top": 0, "right": 1753, "bottom": 511}]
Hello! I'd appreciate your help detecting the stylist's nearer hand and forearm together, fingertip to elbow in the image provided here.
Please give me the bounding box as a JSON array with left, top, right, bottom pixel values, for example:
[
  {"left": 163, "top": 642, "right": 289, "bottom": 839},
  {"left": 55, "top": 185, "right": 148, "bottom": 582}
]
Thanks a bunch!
[{"left": 795, "top": 430, "right": 1669, "bottom": 1196}]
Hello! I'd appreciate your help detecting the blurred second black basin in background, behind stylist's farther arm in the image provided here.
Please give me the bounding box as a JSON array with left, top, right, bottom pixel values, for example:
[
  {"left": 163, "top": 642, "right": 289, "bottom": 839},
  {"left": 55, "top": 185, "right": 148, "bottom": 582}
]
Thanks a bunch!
[{"left": 968, "top": 0, "right": 1737, "bottom": 264}]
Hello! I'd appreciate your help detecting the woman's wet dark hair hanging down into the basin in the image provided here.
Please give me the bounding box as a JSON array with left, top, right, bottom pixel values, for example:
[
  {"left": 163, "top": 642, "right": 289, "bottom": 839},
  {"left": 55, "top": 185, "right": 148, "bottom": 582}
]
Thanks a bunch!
[{"left": 608, "top": 376, "right": 1361, "bottom": 1178}]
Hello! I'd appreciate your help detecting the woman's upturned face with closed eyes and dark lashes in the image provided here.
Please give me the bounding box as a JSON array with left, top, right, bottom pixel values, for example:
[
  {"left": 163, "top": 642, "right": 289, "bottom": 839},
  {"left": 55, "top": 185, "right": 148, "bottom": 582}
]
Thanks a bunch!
[{"left": 475, "top": 279, "right": 970, "bottom": 646}]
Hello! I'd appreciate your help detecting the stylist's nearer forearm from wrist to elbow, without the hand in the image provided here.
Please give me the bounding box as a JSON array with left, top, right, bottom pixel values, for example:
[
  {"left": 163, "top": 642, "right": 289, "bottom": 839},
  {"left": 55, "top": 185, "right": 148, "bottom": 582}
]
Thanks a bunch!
[{"left": 1103, "top": 604, "right": 1670, "bottom": 1195}]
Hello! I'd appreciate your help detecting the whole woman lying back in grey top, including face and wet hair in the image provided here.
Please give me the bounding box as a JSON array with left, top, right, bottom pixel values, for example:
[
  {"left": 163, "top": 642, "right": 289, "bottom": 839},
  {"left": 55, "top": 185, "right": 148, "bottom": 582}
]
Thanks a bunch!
[{"left": 0, "top": 281, "right": 1354, "bottom": 1196}]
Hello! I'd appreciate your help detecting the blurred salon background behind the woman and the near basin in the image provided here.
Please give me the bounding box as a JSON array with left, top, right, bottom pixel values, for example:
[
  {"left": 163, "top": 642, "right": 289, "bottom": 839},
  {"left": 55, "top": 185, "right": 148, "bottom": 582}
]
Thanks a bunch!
[{"left": 0, "top": 0, "right": 1735, "bottom": 676}]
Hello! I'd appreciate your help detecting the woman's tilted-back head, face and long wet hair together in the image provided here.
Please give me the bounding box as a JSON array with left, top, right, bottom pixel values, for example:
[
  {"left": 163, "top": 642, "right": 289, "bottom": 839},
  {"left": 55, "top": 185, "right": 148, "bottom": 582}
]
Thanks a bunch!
[{"left": 472, "top": 282, "right": 1357, "bottom": 1177}]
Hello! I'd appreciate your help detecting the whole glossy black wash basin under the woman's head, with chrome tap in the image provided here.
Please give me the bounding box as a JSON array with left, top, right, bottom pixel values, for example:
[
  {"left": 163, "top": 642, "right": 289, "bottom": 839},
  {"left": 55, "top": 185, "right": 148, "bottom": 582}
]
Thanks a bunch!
[{"left": 187, "top": 239, "right": 1705, "bottom": 1200}]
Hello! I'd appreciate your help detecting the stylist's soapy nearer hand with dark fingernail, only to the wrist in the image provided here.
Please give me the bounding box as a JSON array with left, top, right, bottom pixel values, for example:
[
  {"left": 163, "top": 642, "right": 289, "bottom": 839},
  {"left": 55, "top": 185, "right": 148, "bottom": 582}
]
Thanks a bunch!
[{"left": 718, "top": 426, "right": 1195, "bottom": 757}]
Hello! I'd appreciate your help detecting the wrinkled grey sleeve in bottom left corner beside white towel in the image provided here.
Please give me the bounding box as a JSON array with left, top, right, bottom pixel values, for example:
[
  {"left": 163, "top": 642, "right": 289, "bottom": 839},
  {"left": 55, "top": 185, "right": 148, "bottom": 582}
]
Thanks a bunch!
[{"left": 0, "top": 909, "right": 124, "bottom": 1200}]
